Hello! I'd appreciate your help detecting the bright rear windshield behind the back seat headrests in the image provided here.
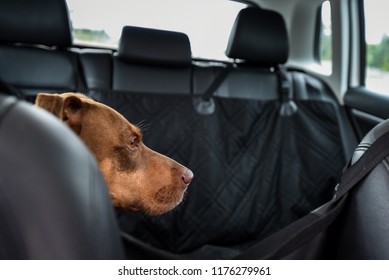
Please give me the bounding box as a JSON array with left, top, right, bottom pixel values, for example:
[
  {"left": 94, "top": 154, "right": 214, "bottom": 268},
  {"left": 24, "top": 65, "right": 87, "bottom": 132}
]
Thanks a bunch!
[{"left": 67, "top": 0, "right": 245, "bottom": 60}]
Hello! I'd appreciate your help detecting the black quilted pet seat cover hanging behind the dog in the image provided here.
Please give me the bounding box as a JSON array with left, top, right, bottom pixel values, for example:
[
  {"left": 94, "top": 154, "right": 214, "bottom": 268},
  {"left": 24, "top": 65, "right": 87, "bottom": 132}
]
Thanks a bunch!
[{"left": 91, "top": 92, "right": 345, "bottom": 259}]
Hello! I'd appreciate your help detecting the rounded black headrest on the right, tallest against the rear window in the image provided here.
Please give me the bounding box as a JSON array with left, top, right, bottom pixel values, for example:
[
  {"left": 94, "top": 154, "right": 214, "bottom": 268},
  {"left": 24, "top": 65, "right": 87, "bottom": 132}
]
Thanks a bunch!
[{"left": 226, "top": 7, "right": 289, "bottom": 66}]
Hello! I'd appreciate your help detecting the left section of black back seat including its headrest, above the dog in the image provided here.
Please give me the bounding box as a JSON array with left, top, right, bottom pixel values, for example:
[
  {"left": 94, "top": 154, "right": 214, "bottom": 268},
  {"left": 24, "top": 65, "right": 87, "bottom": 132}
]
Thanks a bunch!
[{"left": 0, "top": 0, "right": 84, "bottom": 101}]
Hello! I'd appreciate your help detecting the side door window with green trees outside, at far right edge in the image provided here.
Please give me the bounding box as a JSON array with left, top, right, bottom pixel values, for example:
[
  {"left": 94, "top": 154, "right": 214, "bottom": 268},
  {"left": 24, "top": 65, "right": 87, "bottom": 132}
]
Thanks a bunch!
[{"left": 364, "top": 0, "right": 389, "bottom": 92}]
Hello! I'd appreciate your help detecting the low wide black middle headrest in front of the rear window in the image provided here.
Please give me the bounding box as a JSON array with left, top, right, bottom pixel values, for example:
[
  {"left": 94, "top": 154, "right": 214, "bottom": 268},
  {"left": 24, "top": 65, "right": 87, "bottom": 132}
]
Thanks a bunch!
[{"left": 118, "top": 26, "right": 192, "bottom": 66}]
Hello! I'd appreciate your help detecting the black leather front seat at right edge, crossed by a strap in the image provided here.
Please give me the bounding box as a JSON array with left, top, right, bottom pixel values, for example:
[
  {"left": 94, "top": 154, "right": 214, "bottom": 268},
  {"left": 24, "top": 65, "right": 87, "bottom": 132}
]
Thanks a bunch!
[{"left": 338, "top": 120, "right": 389, "bottom": 260}]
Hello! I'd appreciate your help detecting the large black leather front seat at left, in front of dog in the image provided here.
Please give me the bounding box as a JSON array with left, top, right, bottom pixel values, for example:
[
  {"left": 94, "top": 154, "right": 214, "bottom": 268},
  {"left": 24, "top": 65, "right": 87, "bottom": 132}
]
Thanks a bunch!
[{"left": 0, "top": 96, "right": 123, "bottom": 259}]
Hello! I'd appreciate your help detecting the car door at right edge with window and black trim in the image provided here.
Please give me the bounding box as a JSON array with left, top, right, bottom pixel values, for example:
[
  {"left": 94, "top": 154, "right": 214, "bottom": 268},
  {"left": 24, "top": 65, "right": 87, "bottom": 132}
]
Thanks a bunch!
[{"left": 344, "top": 0, "right": 389, "bottom": 137}]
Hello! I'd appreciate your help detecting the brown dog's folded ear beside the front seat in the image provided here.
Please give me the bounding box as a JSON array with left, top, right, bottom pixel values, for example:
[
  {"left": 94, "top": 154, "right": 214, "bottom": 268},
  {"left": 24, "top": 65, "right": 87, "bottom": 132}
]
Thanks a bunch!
[{"left": 35, "top": 93, "right": 83, "bottom": 134}]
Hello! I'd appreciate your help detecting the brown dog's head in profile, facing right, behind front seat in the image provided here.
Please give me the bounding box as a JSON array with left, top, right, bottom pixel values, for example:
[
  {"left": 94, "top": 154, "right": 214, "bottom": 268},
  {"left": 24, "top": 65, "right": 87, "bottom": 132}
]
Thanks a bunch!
[{"left": 35, "top": 93, "right": 193, "bottom": 215}]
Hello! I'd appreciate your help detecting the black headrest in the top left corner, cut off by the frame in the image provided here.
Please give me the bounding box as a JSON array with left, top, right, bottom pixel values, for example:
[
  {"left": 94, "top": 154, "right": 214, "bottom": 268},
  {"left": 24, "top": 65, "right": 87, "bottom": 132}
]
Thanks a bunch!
[{"left": 0, "top": 0, "right": 72, "bottom": 47}]
